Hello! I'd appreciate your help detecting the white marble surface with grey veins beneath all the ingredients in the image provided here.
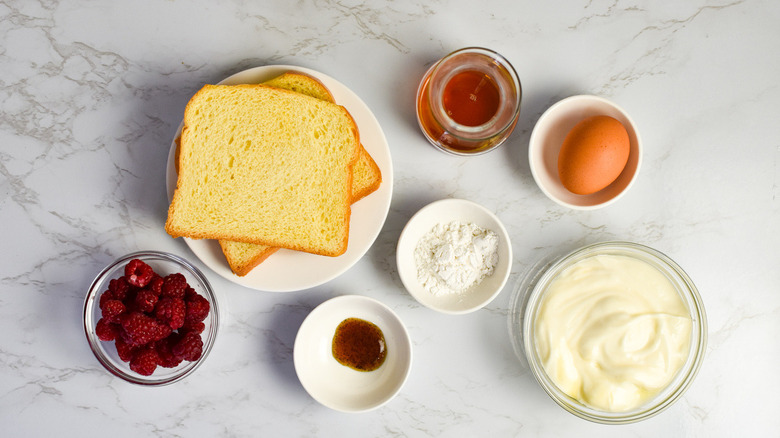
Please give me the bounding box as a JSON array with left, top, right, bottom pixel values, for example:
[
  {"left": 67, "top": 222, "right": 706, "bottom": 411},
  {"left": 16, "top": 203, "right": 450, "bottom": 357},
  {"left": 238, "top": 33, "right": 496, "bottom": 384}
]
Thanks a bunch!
[{"left": 0, "top": 0, "right": 780, "bottom": 437}]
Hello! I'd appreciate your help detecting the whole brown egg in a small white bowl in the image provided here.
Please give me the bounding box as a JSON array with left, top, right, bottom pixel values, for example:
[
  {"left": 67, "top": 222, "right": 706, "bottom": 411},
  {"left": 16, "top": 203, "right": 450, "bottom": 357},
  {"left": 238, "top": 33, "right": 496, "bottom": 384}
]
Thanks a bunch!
[{"left": 558, "top": 116, "right": 630, "bottom": 195}]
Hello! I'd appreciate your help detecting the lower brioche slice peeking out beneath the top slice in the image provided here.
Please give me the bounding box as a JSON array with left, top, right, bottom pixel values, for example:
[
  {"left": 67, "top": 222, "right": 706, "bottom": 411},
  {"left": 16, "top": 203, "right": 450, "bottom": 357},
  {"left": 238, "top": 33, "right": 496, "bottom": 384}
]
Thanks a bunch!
[{"left": 219, "top": 72, "right": 382, "bottom": 277}]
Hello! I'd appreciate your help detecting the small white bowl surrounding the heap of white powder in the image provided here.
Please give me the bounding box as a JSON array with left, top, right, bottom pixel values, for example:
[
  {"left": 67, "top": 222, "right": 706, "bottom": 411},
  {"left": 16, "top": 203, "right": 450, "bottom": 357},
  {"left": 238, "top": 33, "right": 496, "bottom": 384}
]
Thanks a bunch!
[{"left": 396, "top": 199, "right": 512, "bottom": 314}]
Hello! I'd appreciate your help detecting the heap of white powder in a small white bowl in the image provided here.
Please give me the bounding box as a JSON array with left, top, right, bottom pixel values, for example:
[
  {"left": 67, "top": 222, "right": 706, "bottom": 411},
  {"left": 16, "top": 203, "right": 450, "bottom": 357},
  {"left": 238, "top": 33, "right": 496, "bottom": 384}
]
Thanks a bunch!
[{"left": 414, "top": 222, "right": 498, "bottom": 295}]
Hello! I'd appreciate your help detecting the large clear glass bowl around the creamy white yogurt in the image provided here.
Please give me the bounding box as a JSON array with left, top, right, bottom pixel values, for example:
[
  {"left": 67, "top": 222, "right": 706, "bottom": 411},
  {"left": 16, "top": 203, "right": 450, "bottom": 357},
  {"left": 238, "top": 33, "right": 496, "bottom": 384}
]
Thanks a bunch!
[{"left": 509, "top": 242, "right": 707, "bottom": 424}]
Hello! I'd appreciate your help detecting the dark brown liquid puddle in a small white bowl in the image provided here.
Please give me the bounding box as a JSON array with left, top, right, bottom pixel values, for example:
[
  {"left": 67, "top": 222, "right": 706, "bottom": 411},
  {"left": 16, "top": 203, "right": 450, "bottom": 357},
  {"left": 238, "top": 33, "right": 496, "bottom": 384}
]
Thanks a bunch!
[{"left": 332, "top": 318, "right": 387, "bottom": 371}]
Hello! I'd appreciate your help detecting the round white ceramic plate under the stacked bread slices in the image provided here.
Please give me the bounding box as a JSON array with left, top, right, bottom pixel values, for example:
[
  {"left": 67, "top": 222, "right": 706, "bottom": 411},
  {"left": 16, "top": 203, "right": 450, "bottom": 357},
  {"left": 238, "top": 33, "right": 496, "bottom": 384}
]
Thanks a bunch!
[{"left": 167, "top": 65, "right": 393, "bottom": 292}]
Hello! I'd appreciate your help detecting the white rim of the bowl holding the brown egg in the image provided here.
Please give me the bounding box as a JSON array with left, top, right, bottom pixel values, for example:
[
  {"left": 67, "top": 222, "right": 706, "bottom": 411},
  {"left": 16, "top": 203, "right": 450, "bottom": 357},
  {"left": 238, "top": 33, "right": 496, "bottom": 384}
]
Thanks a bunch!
[{"left": 528, "top": 94, "right": 644, "bottom": 210}]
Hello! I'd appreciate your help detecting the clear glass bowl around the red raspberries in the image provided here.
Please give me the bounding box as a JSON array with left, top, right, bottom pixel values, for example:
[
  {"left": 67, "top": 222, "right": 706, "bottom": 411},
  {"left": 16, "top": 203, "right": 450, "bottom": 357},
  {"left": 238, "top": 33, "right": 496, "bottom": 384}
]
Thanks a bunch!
[{"left": 84, "top": 251, "right": 219, "bottom": 386}]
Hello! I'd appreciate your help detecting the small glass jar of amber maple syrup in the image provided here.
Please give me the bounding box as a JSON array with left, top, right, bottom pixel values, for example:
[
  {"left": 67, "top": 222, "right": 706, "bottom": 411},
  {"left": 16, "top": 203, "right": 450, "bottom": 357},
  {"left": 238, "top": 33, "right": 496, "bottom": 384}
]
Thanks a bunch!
[{"left": 417, "top": 47, "right": 522, "bottom": 155}]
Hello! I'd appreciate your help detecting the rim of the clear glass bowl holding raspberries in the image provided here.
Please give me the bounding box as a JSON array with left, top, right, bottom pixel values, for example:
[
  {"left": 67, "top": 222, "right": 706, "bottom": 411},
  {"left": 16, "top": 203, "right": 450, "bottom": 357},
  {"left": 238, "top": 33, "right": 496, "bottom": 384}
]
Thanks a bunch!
[{"left": 82, "top": 250, "right": 219, "bottom": 386}]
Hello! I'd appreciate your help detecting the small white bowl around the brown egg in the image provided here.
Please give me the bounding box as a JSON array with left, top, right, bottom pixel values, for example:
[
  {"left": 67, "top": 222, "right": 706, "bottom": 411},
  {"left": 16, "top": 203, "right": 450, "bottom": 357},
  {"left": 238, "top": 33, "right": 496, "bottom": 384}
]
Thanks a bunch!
[{"left": 528, "top": 95, "right": 642, "bottom": 210}]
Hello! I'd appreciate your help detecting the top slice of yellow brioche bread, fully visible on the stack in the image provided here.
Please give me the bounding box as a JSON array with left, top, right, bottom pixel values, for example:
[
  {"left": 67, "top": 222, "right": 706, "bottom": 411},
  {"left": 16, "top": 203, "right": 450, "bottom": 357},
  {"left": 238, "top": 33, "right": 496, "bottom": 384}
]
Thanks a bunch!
[{"left": 166, "top": 85, "right": 359, "bottom": 256}]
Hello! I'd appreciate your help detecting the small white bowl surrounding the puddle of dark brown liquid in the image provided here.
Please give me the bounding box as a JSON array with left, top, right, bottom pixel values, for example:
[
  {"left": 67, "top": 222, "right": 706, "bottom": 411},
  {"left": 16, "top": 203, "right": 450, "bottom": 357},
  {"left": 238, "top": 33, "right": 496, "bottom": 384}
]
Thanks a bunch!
[{"left": 293, "top": 295, "right": 412, "bottom": 412}]
